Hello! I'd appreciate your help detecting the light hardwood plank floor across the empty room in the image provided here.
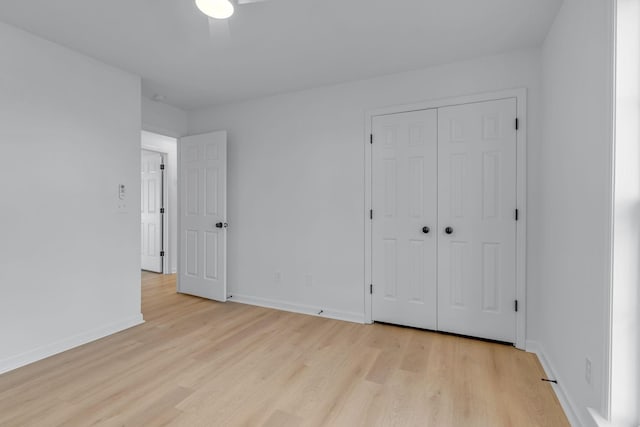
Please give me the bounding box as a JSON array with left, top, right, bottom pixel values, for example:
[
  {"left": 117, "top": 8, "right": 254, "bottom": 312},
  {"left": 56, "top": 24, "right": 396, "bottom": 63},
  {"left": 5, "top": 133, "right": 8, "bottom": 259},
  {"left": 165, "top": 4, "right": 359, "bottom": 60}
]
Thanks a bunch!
[{"left": 0, "top": 273, "right": 568, "bottom": 427}]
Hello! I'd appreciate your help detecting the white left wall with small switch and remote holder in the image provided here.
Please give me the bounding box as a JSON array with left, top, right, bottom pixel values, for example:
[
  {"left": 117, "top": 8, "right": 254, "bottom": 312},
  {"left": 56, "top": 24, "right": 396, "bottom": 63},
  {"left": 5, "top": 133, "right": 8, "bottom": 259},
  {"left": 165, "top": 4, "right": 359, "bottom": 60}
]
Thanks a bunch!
[{"left": 0, "top": 24, "right": 142, "bottom": 372}]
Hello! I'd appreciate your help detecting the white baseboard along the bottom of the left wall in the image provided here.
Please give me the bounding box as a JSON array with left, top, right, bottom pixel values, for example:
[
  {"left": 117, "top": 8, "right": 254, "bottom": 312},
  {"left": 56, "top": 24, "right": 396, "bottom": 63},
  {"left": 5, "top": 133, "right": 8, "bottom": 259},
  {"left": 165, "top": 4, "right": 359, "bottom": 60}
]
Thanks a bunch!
[{"left": 0, "top": 314, "right": 144, "bottom": 374}]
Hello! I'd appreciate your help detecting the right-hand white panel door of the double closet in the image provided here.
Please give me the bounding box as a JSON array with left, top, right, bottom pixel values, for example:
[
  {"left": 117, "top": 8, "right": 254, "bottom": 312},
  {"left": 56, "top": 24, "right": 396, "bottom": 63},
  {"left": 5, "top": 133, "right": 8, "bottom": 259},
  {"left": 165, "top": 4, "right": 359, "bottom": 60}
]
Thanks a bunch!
[{"left": 437, "top": 99, "right": 516, "bottom": 342}]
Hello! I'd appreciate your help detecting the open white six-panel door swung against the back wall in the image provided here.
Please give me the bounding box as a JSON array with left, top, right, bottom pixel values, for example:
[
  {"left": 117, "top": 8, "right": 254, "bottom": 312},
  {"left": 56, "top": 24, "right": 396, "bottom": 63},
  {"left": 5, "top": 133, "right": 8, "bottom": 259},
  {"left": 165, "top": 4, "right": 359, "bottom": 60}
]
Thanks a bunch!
[{"left": 178, "top": 131, "right": 227, "bottom": 301}]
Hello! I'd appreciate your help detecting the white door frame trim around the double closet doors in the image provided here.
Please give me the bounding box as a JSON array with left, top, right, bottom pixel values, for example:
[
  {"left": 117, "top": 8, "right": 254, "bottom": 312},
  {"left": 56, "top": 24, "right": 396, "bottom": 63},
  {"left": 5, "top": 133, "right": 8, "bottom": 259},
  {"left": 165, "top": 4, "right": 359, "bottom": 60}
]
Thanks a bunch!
[{"left": 363, "top": 88, "right": 527, "bottom": 350}]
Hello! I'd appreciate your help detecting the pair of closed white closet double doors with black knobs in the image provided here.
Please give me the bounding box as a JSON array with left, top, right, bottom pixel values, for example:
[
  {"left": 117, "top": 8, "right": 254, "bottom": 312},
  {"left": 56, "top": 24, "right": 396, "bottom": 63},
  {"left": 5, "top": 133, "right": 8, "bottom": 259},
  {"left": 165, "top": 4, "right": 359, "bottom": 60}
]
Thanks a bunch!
[{"left": 365, "top": 91, "right": 526, "bottom": 348}]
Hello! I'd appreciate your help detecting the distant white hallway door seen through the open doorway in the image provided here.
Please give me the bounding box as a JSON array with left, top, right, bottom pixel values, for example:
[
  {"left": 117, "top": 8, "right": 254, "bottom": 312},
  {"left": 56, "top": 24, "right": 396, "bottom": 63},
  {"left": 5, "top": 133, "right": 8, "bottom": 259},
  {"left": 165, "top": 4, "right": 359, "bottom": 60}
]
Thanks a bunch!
[{"left": 140, "top": 150, "right": 162, "bottom": 273}]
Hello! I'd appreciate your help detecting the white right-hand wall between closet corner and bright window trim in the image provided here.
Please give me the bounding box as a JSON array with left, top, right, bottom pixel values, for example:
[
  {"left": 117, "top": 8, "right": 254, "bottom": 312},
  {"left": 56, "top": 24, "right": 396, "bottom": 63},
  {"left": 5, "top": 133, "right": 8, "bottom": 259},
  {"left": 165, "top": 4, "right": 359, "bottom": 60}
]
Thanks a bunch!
[{"left": 529, "top": 0, "right": 612, "bottom": 425}]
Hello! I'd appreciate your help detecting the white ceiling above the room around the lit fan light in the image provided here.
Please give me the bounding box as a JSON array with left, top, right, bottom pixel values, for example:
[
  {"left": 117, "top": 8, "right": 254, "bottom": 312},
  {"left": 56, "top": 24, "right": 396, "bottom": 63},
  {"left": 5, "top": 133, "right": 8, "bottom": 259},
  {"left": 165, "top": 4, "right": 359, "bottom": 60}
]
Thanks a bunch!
[{"left": 0, "top": 0, "right": 562, "bottom": 109}]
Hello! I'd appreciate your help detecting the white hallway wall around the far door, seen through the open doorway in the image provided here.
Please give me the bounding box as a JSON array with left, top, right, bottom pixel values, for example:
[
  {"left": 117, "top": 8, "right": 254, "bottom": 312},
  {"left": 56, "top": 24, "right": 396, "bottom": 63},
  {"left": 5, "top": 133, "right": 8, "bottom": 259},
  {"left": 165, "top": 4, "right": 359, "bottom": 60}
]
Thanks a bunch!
[{"left": 142, "top": 131, "right": 178, "bottom": 274}]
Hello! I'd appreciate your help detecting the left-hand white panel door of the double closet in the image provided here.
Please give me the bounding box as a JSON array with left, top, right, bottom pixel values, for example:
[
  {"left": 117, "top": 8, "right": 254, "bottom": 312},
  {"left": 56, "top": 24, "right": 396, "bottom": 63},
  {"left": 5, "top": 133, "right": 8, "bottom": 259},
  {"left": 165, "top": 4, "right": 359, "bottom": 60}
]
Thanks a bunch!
[{"left": 372, "top": 110, "right": 438, "bottom": 329}]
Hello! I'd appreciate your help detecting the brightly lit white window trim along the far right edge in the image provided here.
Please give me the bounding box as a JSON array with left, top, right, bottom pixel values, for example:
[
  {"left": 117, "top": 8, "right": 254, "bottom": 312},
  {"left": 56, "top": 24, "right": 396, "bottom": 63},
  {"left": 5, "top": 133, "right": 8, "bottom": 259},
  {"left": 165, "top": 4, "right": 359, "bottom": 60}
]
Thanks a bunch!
[{"left": 611, "top": 0, "right": 640, "bottom": 426}]
